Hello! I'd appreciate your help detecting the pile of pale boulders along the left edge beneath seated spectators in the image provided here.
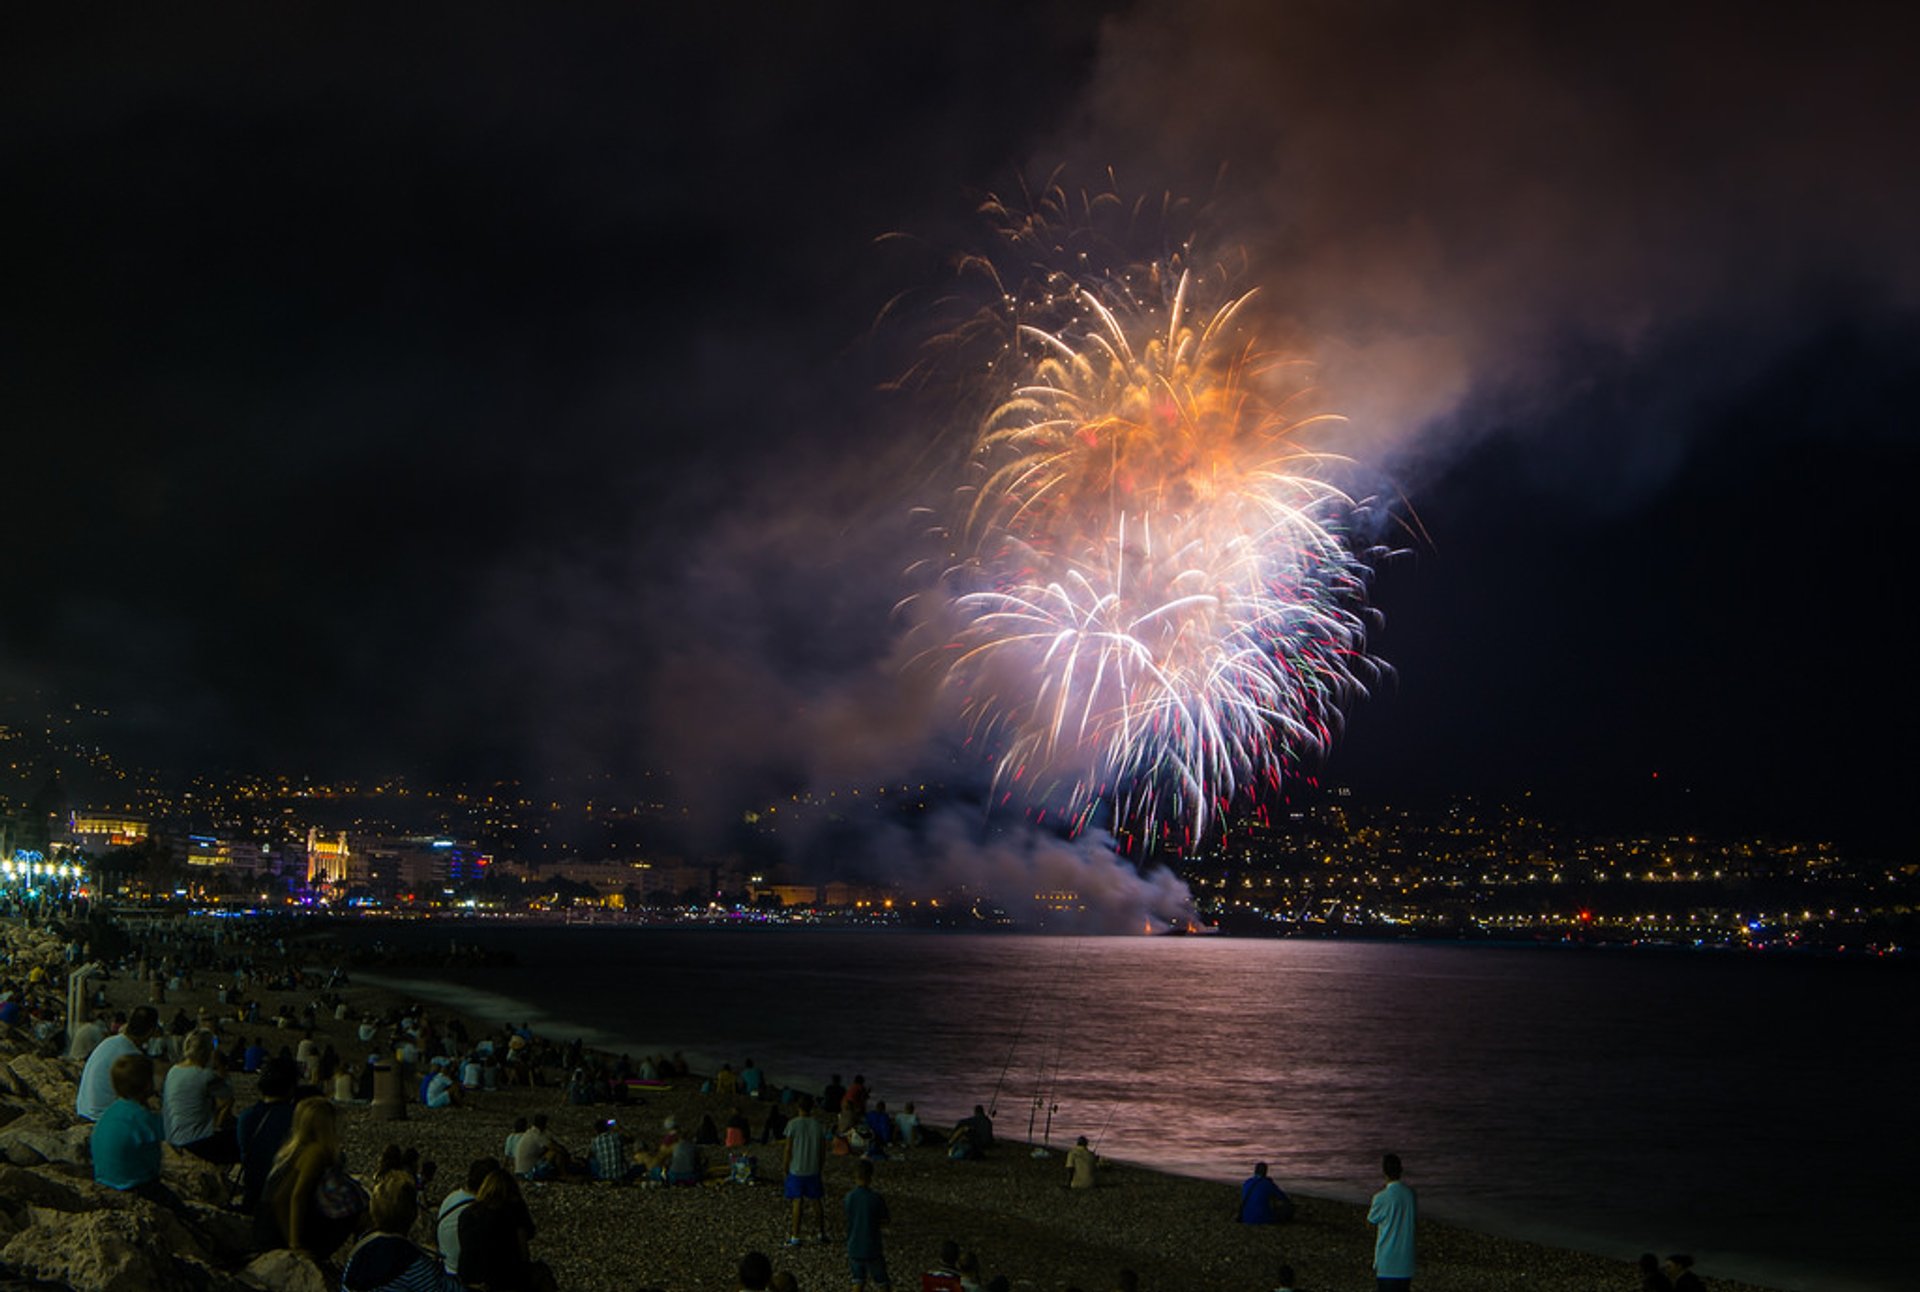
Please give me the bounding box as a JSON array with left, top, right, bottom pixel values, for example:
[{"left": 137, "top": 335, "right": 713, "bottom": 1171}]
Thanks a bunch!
[{"left": 0, "top": 925, "right": 326, "bottom": 1292}]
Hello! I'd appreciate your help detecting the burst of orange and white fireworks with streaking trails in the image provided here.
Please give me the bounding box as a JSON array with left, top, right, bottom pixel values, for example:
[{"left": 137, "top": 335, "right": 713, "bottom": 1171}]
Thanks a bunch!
[{"left": 917, "top": 181, "right": 1379, "bottom": 847}]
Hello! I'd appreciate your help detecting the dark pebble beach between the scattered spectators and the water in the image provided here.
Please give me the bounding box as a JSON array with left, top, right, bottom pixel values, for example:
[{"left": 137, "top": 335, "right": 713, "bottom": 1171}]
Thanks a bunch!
[{"left": 7, "top": 913, "right": 1789, "bottom": 1292}]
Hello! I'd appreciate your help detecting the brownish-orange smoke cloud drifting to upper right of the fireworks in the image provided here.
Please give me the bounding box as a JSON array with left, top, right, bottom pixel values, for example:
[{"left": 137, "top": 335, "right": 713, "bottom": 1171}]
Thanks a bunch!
[{"left": 1054, "top": 0, "right": 1920, "bottom": 493}]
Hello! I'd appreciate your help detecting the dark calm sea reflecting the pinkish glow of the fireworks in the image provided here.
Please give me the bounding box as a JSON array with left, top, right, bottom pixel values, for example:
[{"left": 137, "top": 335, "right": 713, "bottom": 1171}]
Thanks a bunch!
[{"left": 341, "top": 925, "right": 1920, "bottom": 1292}]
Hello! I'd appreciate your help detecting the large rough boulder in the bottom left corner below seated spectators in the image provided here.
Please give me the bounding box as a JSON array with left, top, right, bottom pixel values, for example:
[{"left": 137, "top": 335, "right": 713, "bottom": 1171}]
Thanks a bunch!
[{"left": 0, "top": 1206, "right": 204, "bottom": 1292}]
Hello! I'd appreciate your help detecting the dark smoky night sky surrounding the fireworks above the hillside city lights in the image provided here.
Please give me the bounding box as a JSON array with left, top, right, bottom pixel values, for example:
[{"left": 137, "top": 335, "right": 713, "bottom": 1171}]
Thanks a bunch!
[{"left": 0, "top": 0, "right": 1920, "bottom": 839}]
